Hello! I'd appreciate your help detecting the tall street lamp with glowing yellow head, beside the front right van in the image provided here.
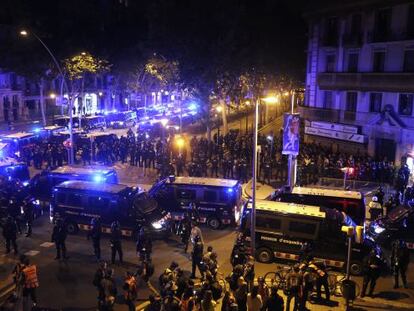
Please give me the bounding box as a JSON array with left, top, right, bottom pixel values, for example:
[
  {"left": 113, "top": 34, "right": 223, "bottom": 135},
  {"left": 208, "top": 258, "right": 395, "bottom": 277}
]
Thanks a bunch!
[{"left": 250, "top": 96, "right": 278, "bottom": 258}]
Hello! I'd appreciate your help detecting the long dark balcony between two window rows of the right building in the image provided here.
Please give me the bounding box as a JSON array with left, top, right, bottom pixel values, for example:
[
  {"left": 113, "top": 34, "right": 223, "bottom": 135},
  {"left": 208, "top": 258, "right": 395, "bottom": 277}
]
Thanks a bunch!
[{"left": 318, "top": 72, "right": 414, "bottom": 93}]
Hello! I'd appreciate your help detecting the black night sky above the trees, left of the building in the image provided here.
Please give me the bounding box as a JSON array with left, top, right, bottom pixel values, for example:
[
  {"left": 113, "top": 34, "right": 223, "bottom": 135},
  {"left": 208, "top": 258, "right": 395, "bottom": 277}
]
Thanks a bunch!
[{"left": 0, "top": 0, "right": 306, "bottom": 80}]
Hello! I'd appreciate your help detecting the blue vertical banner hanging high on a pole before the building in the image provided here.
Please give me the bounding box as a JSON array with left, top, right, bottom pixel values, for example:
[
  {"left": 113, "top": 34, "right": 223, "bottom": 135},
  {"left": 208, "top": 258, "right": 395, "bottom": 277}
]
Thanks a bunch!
[{"left": 282, "top": 113, "right": 300, "bottom": 155}]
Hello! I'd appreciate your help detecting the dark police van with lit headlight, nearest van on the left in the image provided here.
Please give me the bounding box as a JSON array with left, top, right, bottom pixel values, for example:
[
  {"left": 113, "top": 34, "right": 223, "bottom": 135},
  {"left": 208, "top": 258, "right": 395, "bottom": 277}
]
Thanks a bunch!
[{"left": 50, "top": 180, "right": 169, "bottom": 237}]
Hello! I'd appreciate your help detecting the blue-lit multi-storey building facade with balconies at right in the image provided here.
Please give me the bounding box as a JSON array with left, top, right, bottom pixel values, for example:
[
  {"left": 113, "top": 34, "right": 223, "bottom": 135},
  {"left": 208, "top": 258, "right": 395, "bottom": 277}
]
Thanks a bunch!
[{"left": 300, "top": 0, "right": 414, "bottom": 164}]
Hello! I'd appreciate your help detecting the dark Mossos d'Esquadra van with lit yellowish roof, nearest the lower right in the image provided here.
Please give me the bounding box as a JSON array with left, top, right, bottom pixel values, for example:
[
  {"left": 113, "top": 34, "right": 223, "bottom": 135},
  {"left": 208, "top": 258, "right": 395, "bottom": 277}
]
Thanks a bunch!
[{"left": 239, "top": 200, "right": 369, "bottom": 275}]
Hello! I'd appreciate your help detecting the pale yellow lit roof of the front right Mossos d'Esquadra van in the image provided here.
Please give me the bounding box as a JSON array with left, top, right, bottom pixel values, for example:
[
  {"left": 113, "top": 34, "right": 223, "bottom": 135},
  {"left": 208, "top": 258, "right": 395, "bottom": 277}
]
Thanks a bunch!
[{"left": 247, "top": 200, "right": 326, "bottom": 218}]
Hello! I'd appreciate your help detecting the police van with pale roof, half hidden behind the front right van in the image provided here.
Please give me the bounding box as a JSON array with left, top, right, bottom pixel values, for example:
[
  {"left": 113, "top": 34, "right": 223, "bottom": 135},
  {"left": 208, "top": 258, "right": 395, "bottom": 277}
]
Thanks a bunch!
[{"left": 273, "top": 187, "right": 366, "bottom": 225}]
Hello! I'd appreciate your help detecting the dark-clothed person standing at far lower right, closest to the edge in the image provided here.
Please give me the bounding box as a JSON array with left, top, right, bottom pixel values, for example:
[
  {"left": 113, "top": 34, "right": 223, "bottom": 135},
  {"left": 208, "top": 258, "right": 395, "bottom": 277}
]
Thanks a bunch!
[{"left": 391, "top": 240, "right": 410, "bottom": 288}]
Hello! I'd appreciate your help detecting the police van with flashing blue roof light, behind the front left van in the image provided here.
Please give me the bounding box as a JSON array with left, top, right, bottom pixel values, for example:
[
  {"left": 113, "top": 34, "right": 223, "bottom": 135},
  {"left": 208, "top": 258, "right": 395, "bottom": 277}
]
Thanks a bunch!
[{"left": 30, "top": 165, "right": 118, "bottom": 203}]
